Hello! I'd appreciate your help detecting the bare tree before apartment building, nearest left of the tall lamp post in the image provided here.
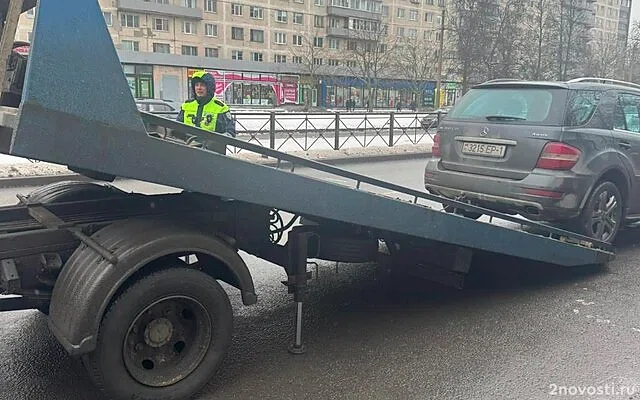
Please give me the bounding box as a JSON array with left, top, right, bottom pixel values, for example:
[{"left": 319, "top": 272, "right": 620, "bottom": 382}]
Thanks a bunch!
[{"left": 393, "top": 38, "right": 438, "bottom": 103}]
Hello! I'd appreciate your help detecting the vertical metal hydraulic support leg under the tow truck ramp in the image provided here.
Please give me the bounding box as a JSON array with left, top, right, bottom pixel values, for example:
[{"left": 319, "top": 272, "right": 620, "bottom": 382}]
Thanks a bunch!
[{"left": 287, "top": 228, "right": 312, "bottom": 354}]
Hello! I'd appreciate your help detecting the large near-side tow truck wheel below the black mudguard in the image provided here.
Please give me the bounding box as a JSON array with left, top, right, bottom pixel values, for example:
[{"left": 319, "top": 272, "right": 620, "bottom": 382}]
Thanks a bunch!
[{"left": 83, "top": 263, "right": 233, "bottom": 400}]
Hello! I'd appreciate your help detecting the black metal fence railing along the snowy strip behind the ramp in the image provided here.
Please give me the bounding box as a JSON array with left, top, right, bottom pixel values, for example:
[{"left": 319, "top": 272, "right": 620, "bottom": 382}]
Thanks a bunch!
[{"left": 148, "top": 112, "right": 445, "bottom": 153}]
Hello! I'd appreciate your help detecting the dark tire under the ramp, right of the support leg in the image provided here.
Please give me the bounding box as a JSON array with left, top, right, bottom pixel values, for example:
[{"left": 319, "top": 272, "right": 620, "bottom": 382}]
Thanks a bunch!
[{"left": 317, "top": 235, "right": 379, "bottom": 263}]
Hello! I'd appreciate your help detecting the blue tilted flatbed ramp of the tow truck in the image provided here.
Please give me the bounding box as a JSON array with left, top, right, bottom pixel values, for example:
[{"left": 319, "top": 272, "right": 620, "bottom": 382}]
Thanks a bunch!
[{"left": 3, "top": 0, "right": 614, "bottom": 266}]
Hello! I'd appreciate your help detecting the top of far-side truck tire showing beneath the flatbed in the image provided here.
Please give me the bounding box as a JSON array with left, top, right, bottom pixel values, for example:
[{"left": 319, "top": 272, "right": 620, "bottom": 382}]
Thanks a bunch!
[{"left": 27, "top": 181, "right": 126, "bottom": 204}]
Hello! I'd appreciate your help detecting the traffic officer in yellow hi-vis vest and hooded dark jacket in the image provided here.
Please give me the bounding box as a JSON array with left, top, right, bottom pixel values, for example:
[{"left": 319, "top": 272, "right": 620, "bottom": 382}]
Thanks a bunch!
[{"left": 177, "top": 70, "right": 236, "bottom": 137}]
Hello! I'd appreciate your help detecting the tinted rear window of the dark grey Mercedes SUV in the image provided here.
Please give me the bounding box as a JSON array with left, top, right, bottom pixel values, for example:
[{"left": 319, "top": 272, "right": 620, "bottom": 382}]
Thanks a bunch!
[{"left": 447, "top": 86, "right": 567, "bottom": 126}]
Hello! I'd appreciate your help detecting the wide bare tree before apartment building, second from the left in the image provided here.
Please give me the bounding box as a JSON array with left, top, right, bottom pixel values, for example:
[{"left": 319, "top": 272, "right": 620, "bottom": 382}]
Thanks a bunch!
[{"left": 343, "top": 17, "right": 397, "bottom": 110}]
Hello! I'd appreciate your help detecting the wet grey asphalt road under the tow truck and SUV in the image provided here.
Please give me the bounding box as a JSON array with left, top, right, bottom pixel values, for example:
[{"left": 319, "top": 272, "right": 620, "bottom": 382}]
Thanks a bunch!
[{"left": 0, "top": 160, "right": 640, "bottom": 400}]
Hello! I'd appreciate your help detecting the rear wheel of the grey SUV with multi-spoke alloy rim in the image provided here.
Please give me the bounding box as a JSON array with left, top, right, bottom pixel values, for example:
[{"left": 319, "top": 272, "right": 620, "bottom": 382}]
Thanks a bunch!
[{"left": 576, "top": 181, "right": 624, "bottom": 243}]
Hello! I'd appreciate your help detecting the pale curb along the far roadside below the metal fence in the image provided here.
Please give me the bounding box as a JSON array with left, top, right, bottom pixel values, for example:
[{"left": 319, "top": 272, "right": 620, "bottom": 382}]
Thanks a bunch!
[{"left": 0, "top": 152, "right": 431, "bottom": 190}]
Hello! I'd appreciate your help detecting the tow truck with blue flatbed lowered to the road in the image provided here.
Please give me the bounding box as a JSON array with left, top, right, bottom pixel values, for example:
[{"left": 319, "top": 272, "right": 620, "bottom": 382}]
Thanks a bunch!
[{"left": 0, "top": 0, "right": 615, "bottom": 400}]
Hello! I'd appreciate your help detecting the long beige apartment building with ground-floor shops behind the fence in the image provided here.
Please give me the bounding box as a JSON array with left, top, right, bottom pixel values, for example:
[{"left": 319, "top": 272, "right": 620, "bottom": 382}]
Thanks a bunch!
[{"left": 16, "top": 0, "right": 455, "bottom": 107}]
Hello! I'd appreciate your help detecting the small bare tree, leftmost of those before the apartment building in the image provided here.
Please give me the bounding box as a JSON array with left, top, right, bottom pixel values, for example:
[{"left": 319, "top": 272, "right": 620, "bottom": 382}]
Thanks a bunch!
[{"left": 289, "top": 28, "right": 328, "bottom": 111}]
